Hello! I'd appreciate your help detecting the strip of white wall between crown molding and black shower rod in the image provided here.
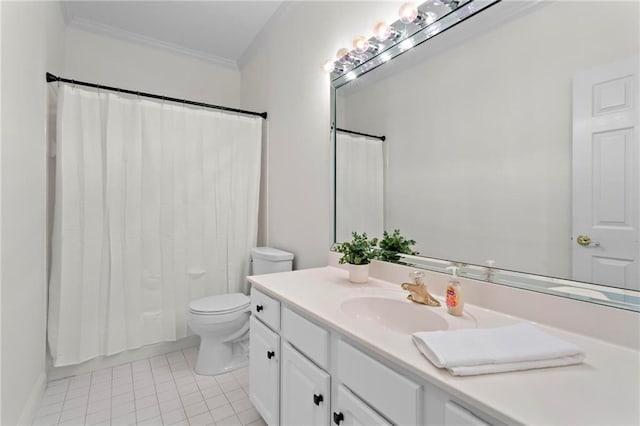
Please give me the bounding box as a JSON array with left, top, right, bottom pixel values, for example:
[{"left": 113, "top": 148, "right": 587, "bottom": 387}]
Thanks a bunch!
[{"left": 63, "top": 28, "right": 240, "bottom": 107}]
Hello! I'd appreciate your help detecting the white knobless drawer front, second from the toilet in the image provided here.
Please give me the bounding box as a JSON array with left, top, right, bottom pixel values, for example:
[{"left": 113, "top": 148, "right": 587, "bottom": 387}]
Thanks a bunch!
[{"left": 282, "top": 307, "right": 329, "bottom": 369}]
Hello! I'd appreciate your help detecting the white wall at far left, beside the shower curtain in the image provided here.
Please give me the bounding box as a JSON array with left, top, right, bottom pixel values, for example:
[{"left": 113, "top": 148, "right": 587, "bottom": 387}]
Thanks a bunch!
[{"left": 0, "top": 1, "right": 64, "bottom": 425}]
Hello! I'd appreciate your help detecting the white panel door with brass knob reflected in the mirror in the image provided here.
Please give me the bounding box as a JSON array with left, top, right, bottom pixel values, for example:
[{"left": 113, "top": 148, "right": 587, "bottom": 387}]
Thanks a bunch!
[{"left": 571, "top": 57, "right": 640, "bottom": 290}]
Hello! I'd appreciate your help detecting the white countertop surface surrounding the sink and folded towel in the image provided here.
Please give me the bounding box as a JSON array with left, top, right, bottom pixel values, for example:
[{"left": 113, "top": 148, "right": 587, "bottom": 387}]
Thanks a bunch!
[{"left": 249, "top": 266, "right": 640, "bottom": 425}]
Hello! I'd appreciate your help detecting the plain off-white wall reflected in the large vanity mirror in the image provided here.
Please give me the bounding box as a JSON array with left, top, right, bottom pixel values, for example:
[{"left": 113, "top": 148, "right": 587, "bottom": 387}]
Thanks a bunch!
[{"left": 344, "top": 2, "right": 639, "bottom": 278}]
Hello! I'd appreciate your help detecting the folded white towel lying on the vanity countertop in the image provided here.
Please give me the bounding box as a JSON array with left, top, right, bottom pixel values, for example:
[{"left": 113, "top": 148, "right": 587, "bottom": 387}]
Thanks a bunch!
[{"left": 413, "top": 323, "right": 585, "bottom": 376}]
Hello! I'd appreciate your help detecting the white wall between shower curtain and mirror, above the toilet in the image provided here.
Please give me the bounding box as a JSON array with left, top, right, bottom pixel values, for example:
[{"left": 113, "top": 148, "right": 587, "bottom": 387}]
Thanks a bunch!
[{"left": 241, "top": 2, "right": 400, "bottom": 269}]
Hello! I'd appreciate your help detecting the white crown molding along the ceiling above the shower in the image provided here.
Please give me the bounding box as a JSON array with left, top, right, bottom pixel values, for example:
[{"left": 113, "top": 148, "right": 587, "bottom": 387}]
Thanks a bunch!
[{"left": 63, "top": 16, "right": 238, "bottom": 70}]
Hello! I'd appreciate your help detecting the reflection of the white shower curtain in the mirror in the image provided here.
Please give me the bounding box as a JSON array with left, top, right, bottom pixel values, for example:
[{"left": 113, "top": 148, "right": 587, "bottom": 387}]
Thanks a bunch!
[{"left": 336, "top": 132, "right": 384, "bottom": 242}]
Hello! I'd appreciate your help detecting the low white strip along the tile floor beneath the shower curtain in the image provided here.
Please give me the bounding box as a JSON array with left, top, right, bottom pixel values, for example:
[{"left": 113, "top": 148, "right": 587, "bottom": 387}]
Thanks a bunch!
[{"left": 47, "top": 335, "right": 200, "bottom": 380}]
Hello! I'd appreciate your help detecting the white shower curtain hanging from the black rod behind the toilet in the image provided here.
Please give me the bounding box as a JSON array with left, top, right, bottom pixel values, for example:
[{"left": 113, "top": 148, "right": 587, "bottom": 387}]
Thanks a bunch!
[{"left": 48, "top": 85, "right": 262, "bottom": 366}]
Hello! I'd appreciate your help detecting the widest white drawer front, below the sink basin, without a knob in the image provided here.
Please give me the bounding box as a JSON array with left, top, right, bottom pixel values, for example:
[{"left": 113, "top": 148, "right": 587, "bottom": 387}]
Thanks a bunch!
[{"left": 338, "top": 341, "right": 422, "bottom": 425}]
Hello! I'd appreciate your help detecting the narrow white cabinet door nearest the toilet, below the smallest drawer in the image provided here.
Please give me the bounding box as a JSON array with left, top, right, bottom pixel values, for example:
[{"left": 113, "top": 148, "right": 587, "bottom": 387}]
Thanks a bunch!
[{"left": 249, "top": 316, "right": 280, "bottom": 426}]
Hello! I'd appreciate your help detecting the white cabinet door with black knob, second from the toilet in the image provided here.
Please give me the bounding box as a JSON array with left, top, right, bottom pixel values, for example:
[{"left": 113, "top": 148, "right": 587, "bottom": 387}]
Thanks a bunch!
[{"left": 282, "top": 343, "right": 331, "bottom": 426}]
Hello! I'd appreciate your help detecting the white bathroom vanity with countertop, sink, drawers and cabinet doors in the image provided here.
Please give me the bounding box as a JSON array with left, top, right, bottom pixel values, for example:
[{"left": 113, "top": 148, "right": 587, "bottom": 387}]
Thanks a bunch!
[{"left": 250, "top": 266, "right": 640, "bottom": 426}]
